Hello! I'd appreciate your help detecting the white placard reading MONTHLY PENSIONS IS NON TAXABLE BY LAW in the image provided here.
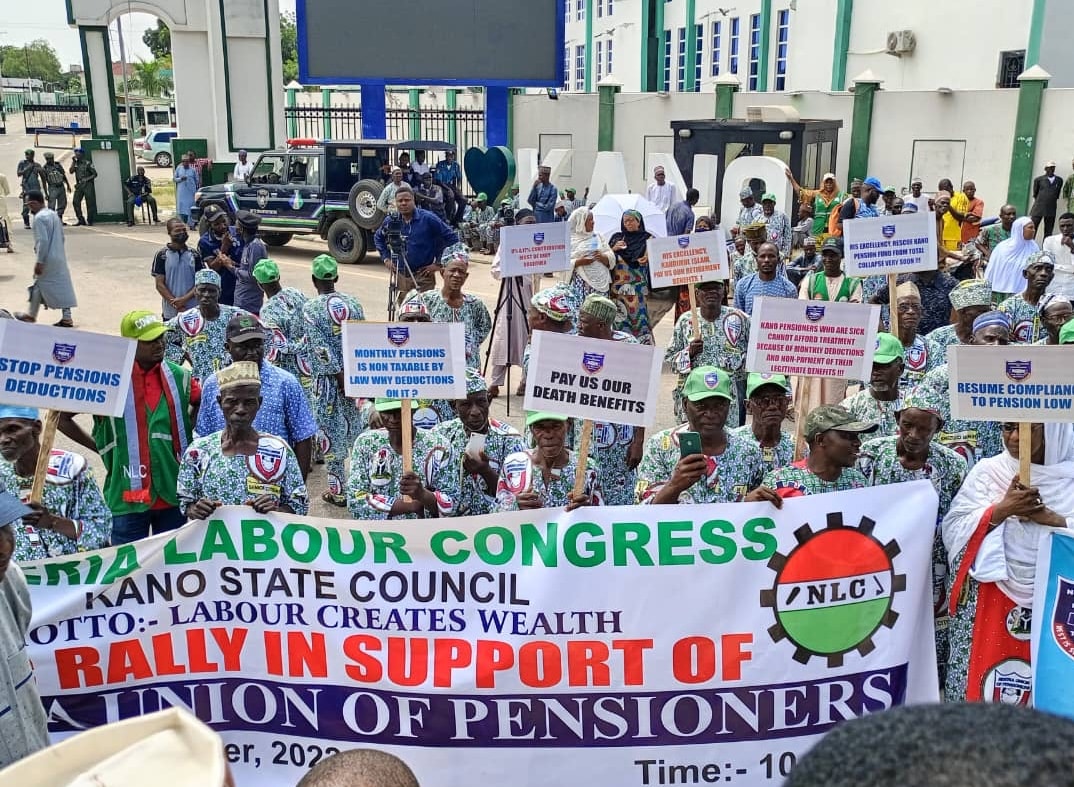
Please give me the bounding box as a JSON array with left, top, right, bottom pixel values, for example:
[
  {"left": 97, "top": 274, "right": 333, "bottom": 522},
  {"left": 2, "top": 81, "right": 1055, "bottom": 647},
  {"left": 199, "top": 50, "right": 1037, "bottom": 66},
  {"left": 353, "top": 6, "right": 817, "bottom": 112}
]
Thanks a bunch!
[{"left": 343, "top": 322, "right": 466, "bottom": 399}]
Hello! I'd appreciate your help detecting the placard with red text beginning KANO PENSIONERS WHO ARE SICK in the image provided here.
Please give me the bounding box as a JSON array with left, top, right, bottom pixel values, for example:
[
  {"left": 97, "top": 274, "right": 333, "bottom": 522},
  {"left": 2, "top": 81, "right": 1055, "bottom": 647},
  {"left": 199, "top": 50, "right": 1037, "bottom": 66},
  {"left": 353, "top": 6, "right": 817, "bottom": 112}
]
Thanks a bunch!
[{"left": 745, "top": 297, "right": 880, "bottom": 380}]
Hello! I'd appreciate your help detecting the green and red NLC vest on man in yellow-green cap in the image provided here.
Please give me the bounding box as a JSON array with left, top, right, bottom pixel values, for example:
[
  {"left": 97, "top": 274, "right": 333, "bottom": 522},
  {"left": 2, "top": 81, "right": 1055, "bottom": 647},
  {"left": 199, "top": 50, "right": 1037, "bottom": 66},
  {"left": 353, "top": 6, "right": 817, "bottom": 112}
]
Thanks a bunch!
[{"left": 93, "top": 361, "right": 193, "bottom": 516}]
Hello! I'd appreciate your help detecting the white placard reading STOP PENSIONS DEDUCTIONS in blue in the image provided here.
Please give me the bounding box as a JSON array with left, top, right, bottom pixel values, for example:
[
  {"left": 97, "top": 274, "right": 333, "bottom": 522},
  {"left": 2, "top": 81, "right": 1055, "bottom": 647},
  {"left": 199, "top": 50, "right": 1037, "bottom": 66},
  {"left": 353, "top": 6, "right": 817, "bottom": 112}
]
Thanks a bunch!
[{"left": 0, "top": 320, "right": 134, "bottom": 417}]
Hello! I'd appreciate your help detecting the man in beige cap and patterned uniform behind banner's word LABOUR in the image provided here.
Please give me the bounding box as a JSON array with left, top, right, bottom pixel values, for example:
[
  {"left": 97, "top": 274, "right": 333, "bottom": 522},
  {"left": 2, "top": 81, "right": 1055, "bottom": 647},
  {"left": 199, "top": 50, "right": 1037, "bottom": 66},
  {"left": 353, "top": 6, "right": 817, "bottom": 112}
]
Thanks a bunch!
[{"left": 176, "top": 361, "right": 309, "bottom": 520}]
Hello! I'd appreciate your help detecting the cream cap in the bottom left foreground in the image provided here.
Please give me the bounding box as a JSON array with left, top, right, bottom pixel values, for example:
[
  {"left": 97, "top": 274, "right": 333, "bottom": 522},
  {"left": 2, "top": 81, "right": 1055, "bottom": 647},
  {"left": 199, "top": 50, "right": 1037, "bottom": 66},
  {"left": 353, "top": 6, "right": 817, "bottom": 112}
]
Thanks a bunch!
[{"left": 0, "top": 708, "right": 227, "bottom": 787}]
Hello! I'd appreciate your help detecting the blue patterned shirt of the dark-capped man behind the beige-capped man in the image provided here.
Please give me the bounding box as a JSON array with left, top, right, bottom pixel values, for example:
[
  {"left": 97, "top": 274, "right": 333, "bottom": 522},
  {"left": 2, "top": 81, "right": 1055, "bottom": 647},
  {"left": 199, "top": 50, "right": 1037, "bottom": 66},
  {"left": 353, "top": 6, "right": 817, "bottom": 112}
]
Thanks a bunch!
[{"left": 194, "top": 361, "right": 317, "bottom": 448}]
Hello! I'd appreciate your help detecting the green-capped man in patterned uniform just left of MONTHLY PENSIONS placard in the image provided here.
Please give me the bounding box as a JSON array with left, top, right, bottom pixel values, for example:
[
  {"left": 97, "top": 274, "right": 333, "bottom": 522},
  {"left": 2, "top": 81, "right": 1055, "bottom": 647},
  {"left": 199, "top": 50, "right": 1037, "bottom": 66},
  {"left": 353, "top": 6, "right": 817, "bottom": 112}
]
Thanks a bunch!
[{"left": 302, "top": 254, "right": 365, "bottom": 507}]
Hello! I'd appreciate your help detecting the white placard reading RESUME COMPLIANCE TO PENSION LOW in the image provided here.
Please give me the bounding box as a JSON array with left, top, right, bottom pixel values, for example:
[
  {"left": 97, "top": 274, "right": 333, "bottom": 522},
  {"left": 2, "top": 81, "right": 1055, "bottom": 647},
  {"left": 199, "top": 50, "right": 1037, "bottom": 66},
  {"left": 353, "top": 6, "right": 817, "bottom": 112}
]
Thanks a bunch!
[{"left": 947, "top": 345, "right": 1074, "bottom": 422}]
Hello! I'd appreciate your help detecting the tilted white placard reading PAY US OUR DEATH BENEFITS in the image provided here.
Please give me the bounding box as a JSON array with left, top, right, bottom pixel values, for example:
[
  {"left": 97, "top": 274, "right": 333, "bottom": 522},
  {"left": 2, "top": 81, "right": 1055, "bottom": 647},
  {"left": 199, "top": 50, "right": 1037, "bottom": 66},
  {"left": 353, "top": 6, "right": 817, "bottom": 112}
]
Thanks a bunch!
[{"left": 522, "top": 331, "right": 662, "bottom": 426}]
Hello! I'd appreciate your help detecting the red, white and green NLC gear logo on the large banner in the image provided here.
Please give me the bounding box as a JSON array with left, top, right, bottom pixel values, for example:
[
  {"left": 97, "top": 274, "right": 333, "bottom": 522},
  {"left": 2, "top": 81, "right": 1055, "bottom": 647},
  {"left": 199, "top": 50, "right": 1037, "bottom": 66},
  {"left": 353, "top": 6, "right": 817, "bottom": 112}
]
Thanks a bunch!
[{"left": 760, "top": 512, "right": 906, "bottom": 667}]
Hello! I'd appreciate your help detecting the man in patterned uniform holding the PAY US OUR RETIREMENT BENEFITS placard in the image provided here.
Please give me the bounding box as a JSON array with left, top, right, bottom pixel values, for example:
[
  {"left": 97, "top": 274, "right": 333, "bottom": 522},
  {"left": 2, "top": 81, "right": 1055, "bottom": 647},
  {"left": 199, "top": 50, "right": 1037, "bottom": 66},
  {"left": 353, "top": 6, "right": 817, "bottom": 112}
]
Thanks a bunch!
[{"left": 664, "top": 281, "right": 750, "bottom": 426}]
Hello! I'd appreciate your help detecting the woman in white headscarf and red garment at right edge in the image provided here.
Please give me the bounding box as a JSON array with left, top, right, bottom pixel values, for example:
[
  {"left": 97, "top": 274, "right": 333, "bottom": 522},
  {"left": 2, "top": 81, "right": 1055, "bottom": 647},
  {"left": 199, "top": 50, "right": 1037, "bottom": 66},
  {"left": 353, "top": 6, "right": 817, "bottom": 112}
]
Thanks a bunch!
[{"left": 942, "top": 423, "right": 1074, "bottom": 704}]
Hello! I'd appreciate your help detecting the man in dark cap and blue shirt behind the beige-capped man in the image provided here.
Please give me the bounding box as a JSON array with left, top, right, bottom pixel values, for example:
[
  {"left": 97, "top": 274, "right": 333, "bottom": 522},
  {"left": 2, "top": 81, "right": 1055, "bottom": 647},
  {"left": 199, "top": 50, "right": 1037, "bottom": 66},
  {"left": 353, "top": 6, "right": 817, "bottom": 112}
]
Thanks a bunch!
[{"left": 194, "top": 314, "right": 317, "bottom": 478}]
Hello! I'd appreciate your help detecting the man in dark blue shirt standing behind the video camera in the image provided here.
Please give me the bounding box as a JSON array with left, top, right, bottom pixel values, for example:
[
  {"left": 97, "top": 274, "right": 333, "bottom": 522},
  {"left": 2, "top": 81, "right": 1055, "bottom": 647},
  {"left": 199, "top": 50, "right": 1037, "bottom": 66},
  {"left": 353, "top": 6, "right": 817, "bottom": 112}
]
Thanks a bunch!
[{"left": 373, "top": 185, "right": 459, "bottom": 305}]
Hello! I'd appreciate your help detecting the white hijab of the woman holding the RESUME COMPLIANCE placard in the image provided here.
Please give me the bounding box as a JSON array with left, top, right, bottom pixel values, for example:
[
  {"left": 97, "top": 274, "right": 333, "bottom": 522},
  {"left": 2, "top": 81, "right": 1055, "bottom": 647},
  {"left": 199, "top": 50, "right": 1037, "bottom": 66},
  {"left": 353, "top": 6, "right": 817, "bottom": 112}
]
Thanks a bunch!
[{"left": 941, "top": 423, "right": 1074, "bottom": 608}]
